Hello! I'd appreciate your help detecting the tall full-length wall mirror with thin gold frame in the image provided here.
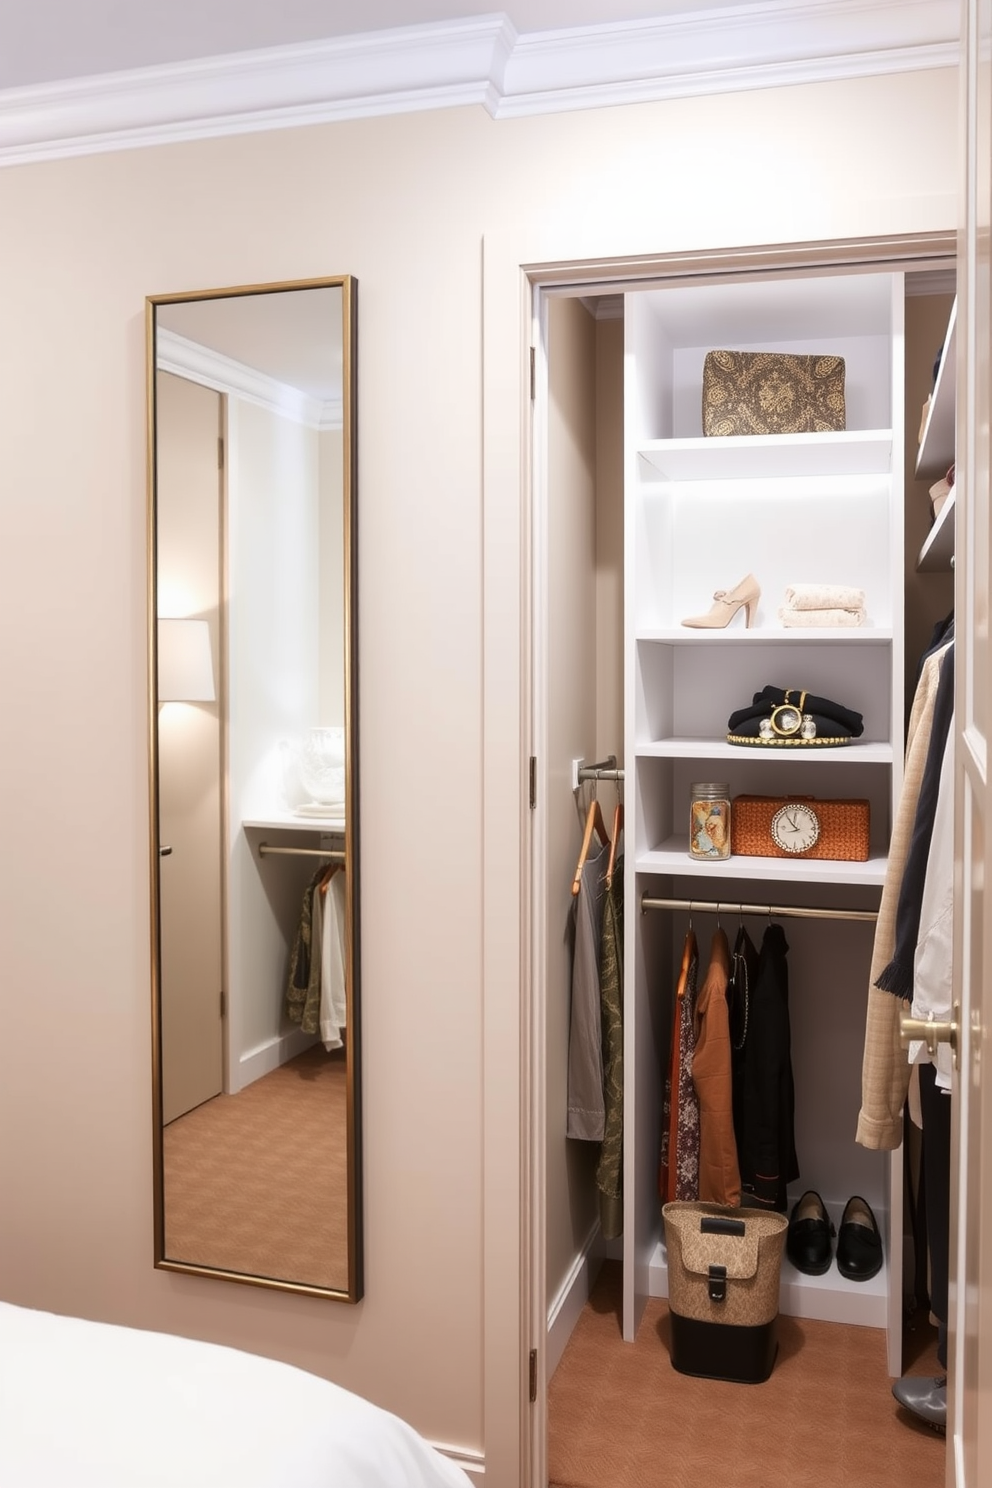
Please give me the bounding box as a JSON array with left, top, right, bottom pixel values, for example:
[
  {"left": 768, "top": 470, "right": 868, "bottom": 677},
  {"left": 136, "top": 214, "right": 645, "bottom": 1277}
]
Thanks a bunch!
[{"left": 147, "top": 277, "right": 363, "bottom": 1302}]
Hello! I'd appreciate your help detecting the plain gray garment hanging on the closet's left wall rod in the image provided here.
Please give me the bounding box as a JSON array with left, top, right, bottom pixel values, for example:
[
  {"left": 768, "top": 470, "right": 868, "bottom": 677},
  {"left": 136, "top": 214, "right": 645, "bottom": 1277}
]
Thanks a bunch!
[{"left": 565, "top": 842, "right": 610, "bottom": 1141}]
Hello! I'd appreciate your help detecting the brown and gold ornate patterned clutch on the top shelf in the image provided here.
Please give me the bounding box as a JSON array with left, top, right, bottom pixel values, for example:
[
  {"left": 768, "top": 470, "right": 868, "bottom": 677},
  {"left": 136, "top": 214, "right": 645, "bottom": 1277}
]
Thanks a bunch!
[{"left": 702, "top": 351, "right": 846, "bottom": 434}]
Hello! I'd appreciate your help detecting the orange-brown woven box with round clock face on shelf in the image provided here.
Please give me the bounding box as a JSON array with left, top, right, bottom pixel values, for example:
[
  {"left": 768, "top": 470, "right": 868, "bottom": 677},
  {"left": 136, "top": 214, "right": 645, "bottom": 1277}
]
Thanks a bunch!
[{"left": 730, "top": 796, "right": 872, "bottom": 863}]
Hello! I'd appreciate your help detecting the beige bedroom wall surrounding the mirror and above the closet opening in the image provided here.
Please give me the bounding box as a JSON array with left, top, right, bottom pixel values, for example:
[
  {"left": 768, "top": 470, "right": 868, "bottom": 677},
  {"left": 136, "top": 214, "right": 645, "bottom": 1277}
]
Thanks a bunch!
[{"left": 0, "top": 63, "right": 956, "bottom": 1488}]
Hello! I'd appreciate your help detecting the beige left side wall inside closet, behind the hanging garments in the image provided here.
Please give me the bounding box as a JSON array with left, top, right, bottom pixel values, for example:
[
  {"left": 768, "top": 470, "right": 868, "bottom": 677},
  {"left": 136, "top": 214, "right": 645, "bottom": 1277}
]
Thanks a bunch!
[{"left": 547, "top": 296, "right": 623, "bottom": 1378}]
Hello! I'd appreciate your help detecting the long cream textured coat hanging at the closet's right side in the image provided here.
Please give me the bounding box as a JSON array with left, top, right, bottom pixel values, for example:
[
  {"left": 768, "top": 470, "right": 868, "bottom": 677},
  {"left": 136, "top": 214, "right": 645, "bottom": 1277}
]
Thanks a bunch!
[{"left": 857, "top": 647, "right": 947, "bottom": 1150}]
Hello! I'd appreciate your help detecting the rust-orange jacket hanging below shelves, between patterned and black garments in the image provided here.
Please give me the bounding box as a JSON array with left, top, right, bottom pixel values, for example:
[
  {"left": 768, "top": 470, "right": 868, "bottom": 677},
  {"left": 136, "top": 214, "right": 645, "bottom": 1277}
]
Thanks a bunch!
[{"left": 693, "top": 929, "right": 741, "bottom": 1204}]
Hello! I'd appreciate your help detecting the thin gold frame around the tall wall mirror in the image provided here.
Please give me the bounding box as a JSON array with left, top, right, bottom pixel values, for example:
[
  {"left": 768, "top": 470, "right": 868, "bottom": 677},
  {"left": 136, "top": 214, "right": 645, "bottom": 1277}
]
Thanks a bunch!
[{"left": 146, "top": 275, "right": 364, "bottom": 1302}]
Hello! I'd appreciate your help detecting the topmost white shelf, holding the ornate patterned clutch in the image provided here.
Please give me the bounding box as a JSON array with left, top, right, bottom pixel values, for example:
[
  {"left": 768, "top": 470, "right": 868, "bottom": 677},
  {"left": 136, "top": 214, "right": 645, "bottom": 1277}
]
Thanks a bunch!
[{"left": 638, "top": 429, "right": 892, "bottom": 481}]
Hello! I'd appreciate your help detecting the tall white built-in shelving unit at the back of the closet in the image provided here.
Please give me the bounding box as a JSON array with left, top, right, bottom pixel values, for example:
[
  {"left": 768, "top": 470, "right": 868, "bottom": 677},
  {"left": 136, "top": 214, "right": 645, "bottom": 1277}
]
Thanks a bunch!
[{"left": 623, "top": 274, "right": 904, "bottom": 1372}]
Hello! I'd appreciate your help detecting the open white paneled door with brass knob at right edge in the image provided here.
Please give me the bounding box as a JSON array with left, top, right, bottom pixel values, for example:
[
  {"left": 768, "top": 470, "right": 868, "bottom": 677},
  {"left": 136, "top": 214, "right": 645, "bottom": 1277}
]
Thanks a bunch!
[{"left": 947, "top": 0, "right": 992, "bottom": 1488}]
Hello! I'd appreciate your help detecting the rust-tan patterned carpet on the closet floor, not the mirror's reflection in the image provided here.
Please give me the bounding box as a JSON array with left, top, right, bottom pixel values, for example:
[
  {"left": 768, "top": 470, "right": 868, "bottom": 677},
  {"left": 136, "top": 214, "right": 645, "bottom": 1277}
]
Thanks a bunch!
[{"left": 549, "top": 1263, "right": 944, "bottom": 1488}]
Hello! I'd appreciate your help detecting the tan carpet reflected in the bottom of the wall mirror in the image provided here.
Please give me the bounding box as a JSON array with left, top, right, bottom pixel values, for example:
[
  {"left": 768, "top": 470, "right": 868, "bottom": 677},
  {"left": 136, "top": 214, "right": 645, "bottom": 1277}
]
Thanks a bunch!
[{"left": 164, "top": 1045, "right": 348, "bottom": 1287}]
